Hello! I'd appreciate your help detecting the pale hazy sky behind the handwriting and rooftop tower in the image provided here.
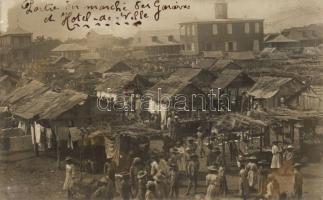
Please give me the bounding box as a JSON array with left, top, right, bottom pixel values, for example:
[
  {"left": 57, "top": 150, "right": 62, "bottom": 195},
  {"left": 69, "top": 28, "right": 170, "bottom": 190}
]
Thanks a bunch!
[{"left": 0, "top": 0, "right": 323, "bottom": 39}]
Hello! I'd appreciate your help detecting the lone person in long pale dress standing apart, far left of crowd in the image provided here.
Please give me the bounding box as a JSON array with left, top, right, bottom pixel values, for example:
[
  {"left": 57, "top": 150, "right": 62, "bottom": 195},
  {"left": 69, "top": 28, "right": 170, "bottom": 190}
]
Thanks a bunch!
[{"left": 63, "top": 156, "right": 75, "bottom": 199}]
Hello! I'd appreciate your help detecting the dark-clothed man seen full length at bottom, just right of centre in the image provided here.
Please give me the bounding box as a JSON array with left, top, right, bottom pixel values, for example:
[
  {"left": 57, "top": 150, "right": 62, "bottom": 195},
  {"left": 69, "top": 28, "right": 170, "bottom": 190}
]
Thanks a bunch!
[{"left": 186, "top": 153, "right": 200, "bottom": 195}]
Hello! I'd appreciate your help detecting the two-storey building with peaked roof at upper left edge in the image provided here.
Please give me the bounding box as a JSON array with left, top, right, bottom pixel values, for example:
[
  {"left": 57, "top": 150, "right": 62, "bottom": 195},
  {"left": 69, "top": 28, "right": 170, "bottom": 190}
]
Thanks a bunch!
[{"left": 0, "top": 26, "right": 32, "bottom": 63}]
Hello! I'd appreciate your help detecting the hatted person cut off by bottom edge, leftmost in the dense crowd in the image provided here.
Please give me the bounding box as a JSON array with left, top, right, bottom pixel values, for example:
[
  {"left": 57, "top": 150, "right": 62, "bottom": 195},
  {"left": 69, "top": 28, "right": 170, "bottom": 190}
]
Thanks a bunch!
[{"left": 91, "top": 177, "right": 115, "bottom": 200}]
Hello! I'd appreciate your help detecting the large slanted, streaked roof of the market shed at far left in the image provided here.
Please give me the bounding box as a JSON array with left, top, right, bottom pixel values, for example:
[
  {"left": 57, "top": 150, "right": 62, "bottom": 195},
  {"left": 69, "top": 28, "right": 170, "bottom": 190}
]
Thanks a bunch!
[{"left": 5, "top": 80, "right": 87, "bottom": 119}]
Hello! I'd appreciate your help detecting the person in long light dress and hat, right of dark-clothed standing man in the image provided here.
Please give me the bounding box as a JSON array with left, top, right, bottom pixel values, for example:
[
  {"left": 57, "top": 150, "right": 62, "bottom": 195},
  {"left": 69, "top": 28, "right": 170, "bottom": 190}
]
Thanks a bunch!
[{"left": 205, "top": 166, "right": 219, "bottom": 200}]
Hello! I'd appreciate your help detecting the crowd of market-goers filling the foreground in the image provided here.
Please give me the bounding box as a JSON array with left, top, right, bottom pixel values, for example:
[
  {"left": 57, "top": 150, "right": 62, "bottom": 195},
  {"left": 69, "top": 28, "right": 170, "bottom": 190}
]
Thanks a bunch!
[{"left": 63, "top": 127, "right": 303, "bottom": 200}]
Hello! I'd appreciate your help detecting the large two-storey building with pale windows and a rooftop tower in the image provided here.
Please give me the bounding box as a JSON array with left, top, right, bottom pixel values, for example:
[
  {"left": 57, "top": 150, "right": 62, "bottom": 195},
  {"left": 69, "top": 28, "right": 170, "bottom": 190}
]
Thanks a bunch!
[{"left": 180, "top": 1, "right": 264, "bottom": 54}]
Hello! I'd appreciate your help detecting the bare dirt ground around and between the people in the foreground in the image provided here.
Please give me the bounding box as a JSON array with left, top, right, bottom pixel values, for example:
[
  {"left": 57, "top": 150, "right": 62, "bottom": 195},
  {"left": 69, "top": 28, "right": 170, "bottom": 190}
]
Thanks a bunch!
[{"left": 0, "top": 151, "right": 323, "bottom": 200}]
